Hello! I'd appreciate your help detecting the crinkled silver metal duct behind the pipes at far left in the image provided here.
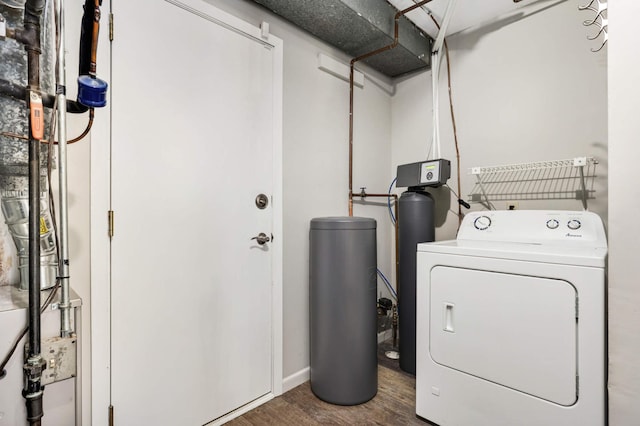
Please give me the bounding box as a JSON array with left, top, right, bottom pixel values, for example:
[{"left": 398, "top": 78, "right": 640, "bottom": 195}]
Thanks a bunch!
[{"left": 0, "top": 1, "right": 58, "bottom": 290}]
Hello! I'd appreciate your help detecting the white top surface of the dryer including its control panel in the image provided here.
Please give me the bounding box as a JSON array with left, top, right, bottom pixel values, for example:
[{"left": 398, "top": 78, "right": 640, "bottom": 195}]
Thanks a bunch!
[{"left": 418, "top": 210, "right": 607, "bottom": 267}]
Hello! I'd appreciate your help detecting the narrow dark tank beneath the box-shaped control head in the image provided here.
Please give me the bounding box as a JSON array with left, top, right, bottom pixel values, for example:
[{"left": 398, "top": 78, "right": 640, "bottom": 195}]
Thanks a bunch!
[{"left": 398, "top": 191, "right": 435, "bottom": 374}]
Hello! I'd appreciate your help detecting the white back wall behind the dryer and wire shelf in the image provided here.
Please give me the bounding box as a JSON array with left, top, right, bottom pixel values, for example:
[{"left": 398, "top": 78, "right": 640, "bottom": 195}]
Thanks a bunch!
[{"left": 392, "top": 0, "right": 608, "bottom": 240}]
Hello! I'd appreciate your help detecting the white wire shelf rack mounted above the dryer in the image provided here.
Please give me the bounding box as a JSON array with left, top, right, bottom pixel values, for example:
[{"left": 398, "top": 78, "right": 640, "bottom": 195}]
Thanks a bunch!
[{"left": 469, "top": 157, "right": 598, "bottom": 209}]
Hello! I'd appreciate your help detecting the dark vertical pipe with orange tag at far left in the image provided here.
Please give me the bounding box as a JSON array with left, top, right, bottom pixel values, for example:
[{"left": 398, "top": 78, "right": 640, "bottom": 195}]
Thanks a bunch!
[{"left": 18, "top": 0, "right": 46, "bottom": 426}]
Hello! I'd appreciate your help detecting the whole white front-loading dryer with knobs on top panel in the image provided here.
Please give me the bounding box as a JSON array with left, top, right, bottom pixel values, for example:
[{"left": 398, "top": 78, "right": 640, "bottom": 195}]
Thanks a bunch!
[{"left": 416, "top": 210, "right": 607, "bottom": 426}]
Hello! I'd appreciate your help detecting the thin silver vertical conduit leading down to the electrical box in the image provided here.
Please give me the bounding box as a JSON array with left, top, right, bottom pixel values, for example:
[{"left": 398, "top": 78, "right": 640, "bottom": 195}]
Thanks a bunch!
[{"left": 55, "top": 0, "right": 72, "bottom": 337}]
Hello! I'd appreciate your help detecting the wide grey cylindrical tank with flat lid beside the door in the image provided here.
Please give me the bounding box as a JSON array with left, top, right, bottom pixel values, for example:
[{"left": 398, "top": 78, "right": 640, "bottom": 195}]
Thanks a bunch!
[{"left": 309, "top": 217, "right": 378, "bottom": 405}]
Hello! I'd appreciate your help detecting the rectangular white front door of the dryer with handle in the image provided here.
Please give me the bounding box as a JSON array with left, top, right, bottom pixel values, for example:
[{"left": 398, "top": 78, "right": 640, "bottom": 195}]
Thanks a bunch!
[{"left": 429, "top": 266, "right": 577, "bottom": 406}]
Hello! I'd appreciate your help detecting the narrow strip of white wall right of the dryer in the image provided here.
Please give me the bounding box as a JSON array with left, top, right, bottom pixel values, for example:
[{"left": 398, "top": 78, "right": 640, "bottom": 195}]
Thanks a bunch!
[{"left": 609, "top": 1, "right": 640, "bottom": 426}]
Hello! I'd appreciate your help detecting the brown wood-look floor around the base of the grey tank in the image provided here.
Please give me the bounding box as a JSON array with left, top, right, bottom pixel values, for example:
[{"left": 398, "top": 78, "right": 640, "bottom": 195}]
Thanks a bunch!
[{"left": 227, "top": 343, "right": 429, "bottom": 426}]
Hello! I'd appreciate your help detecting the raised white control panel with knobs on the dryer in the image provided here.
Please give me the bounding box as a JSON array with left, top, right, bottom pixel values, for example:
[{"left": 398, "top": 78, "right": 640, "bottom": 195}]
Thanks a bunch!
[{"left": 458, "top": 210, "right": 606, "bottom": 246}]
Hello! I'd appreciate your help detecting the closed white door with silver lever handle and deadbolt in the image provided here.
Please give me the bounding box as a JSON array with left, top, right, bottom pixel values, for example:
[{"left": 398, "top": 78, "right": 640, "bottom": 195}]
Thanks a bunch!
[{"left": 111, "top": 0, "right": 278, "bottom": 425}]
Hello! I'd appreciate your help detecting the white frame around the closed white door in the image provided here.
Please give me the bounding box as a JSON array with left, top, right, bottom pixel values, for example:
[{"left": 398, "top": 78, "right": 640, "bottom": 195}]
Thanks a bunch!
[{"left": 90, "top": 0, "right": 283, "bottom": 426}]
